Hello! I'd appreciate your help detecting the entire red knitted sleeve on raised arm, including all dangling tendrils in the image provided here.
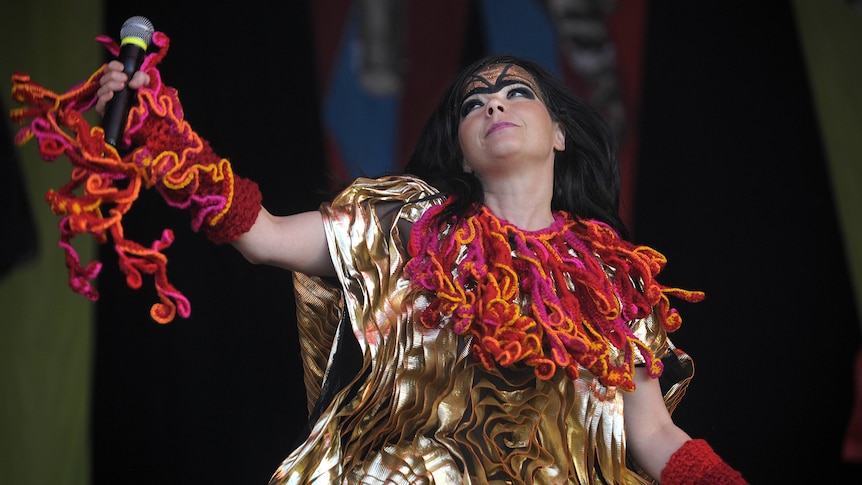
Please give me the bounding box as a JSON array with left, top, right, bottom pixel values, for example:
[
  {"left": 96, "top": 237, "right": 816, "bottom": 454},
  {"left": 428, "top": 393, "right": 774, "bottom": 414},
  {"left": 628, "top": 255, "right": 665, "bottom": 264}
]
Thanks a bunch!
[{"left": 10, "top": 32, "right": 261, "bottom": 323}]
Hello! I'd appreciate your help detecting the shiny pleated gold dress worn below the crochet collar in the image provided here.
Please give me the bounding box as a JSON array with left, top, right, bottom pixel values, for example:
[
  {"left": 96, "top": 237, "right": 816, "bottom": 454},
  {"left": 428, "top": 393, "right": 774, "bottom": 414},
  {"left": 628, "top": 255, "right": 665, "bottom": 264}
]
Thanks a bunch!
[{"left": 270, "top": 177, "right": 691, "bottom": 485}]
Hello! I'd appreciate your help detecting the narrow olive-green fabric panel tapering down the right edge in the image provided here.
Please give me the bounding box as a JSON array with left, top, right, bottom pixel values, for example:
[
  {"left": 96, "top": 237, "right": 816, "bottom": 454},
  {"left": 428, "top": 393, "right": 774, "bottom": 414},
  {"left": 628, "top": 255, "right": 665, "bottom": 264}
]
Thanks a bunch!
[{"left": 788, "top": 0, "right": 862, "bottom": 323}]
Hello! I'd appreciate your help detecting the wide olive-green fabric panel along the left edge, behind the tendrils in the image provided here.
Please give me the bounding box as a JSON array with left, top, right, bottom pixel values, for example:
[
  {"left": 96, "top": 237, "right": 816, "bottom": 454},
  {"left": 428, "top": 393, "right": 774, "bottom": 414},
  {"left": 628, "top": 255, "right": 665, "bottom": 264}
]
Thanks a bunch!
[{"left": 0, "top": 0, "right": 104, "bottom": 485}]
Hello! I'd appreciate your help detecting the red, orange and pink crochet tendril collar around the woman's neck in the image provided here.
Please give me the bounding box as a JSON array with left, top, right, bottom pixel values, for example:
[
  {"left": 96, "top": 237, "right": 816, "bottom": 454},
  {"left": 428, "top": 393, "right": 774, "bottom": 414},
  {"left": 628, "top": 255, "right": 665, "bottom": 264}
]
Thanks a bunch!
[{"left": 406, "top": 200, "right": 704, "bottom": 390}]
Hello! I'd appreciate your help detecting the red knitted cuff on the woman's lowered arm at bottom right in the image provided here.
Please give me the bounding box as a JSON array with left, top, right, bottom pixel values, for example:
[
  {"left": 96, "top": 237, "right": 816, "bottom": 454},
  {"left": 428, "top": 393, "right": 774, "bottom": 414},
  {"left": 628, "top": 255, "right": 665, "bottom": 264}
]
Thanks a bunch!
[{"left": 661, "top": 439, "right": 748, "bottom": 485}]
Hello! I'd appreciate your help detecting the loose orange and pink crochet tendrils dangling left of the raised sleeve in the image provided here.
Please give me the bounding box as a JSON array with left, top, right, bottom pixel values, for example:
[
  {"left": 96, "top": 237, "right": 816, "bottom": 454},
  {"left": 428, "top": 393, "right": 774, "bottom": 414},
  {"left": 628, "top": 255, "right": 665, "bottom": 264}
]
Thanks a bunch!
[{"left": 10, "top": 32, "right": 191, "bottom": 323}]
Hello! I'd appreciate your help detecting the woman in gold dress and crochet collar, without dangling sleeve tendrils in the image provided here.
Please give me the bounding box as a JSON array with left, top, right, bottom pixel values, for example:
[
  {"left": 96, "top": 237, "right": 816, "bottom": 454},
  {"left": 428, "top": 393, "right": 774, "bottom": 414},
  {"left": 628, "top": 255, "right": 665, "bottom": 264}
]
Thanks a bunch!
[{"left": 27, "top": 36, "right": 745, "bottom": 484}]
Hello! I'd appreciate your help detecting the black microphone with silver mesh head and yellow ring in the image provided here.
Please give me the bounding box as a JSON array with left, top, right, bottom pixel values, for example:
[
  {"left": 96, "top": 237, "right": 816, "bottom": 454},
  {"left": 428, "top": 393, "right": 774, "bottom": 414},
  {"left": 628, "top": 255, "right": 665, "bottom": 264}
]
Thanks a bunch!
[{"left": 102, "top": 16, "right": 155, "bottom": 147}]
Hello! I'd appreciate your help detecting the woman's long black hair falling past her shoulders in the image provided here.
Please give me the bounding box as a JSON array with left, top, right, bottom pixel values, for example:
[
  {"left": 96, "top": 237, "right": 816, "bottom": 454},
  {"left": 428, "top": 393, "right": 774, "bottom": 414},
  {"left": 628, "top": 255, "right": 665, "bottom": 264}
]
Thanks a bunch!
[{"left": 404, "top": 55, "right": 628, "bottom": 239}]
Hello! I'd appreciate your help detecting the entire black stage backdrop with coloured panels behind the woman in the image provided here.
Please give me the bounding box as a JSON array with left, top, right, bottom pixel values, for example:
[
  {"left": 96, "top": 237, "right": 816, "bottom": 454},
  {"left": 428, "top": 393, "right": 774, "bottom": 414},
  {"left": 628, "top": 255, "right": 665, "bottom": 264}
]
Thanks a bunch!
[{"left": 0, "top": 0, "right": 862, "bottom": 485}]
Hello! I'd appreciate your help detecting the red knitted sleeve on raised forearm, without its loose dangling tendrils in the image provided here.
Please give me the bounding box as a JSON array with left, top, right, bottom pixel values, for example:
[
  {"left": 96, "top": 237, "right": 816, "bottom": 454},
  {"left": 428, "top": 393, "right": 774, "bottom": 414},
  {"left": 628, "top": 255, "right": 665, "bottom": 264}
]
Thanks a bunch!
[{"left": 123, "top": 69, "right": 261, "bottom": 244}]
